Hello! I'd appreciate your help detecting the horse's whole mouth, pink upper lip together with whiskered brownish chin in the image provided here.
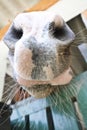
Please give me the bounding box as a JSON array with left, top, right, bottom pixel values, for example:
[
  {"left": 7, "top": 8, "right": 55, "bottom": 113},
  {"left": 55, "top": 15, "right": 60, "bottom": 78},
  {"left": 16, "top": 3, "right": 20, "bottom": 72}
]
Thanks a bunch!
[{"left": 17, "top": 68, "right": 73, "bottom": 98}]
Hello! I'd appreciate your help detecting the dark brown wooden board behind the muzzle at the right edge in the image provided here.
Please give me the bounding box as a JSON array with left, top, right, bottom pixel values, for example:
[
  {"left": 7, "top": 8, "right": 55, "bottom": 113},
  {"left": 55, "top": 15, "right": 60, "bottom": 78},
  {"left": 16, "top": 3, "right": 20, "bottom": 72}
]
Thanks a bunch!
[{"left": 67, "top": 15, "right": 87, "bottom": 74}]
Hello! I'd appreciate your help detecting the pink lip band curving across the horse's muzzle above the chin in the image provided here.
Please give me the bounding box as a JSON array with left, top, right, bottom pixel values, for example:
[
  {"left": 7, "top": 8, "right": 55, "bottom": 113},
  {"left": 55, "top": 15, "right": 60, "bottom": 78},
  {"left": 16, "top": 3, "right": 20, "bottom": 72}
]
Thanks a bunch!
[{"left": 17, "top": 68, "right": 73, "bottom": 87}]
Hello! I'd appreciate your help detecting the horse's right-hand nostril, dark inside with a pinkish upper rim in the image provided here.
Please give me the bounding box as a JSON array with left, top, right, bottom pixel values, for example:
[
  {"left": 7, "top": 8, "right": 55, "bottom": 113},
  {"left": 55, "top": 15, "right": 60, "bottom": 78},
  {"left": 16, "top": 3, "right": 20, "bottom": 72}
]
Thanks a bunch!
[{"left": 49, "top": 16, "right": 75, "bottom": 43}]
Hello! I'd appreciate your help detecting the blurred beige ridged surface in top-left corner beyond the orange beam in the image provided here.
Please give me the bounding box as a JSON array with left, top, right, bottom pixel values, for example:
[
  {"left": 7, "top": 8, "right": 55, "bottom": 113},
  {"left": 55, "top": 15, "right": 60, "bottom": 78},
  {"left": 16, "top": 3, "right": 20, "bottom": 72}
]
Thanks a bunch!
[{"left": 0, "top": 0, "right": 40, "bottom": 29}]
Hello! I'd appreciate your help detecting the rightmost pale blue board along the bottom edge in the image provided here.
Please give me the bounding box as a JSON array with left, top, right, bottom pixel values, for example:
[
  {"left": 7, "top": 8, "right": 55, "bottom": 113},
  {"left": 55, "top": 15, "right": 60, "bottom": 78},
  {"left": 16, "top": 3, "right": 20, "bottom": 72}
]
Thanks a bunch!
[{"left": 52, "top": 107, "right": 79, "bottom": 130}]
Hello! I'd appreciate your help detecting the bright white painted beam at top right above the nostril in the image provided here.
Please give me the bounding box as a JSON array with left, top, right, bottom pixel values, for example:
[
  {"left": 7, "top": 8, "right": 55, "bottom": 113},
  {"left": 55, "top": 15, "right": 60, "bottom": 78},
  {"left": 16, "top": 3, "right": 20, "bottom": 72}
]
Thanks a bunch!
[{"left": 48, "top": 0, "right": 87, "bottom": 22}]
